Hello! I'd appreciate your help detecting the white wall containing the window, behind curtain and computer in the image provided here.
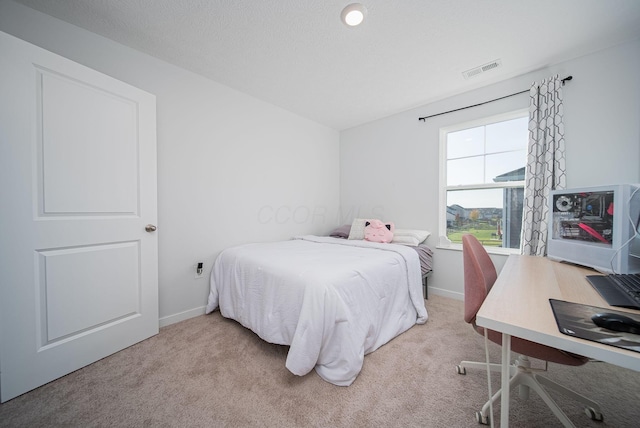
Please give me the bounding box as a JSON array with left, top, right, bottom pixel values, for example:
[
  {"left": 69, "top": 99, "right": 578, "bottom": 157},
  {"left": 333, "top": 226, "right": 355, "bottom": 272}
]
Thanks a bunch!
[{"left": 340, "top": 40, "right": 640, "bottom": 298}]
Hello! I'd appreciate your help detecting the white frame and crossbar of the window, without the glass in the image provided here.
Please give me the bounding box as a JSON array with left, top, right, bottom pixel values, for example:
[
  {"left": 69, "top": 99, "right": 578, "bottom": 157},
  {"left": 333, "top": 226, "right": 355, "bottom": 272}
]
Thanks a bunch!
[{"left": 436, "top": 108, "right": 529, "bottom": 255}]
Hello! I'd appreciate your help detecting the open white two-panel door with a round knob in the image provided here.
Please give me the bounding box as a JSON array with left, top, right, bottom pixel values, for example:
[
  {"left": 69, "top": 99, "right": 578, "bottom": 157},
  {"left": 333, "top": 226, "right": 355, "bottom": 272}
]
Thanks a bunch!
[{"left": 0, "top": 32, "right": 158, "bottom": 402}]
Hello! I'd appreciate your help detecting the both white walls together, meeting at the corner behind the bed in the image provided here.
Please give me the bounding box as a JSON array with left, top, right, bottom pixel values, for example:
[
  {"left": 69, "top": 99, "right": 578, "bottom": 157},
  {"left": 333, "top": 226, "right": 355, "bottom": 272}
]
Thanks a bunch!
[{"left": 5, "top": 0, "right": 640, "bottom": 314}]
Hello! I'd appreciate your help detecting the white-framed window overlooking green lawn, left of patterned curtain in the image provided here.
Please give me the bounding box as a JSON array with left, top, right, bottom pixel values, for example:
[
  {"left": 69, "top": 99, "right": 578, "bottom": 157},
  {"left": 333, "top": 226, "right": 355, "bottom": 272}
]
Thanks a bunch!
[{"left": 440, "top": 110, "right": 529, "bottom": 252}]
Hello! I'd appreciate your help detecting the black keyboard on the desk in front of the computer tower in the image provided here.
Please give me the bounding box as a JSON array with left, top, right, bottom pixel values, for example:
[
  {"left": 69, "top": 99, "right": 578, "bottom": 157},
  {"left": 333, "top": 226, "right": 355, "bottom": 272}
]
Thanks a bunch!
[{"left": 587, "top": 273, "right": 640, "bottom": 309}]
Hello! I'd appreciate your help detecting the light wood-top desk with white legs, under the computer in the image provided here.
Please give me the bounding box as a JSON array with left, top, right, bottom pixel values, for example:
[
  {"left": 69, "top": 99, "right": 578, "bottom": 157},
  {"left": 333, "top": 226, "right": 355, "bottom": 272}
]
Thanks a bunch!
[{"left": 476, "top": 255, "right": 640, "bottom": 427}]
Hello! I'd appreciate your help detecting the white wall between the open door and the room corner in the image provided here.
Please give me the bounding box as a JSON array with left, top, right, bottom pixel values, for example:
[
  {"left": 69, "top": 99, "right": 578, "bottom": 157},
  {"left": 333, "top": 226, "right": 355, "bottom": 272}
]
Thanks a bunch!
[{"left": 0, "top": 0, "right": 339, "bottom": 325}]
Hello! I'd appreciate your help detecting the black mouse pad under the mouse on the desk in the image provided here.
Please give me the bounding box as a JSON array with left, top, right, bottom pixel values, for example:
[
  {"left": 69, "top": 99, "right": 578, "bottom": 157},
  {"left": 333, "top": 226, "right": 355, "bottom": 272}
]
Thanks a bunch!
[{"left": 549, "top": 299, "right": 640, "bottom": 352}]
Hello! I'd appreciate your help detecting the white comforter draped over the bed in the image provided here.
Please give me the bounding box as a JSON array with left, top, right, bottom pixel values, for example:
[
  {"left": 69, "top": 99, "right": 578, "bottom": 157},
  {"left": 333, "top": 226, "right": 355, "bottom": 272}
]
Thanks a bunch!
[{"left": 206, "top": 236, "right": 427, "bottom": 386}]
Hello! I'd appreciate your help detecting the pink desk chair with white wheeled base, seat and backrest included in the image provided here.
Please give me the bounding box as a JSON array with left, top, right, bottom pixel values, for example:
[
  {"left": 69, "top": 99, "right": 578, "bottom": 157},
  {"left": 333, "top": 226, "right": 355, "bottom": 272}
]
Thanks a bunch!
[{"left": 456, "top": 235, "right": 603, "bottom": 427}]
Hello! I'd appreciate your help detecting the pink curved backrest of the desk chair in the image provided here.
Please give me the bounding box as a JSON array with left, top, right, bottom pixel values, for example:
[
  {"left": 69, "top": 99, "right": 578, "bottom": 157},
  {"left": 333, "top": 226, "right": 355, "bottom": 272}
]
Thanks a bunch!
[{"left": 462, "top": 235, "right": 498, "bottom": 323}]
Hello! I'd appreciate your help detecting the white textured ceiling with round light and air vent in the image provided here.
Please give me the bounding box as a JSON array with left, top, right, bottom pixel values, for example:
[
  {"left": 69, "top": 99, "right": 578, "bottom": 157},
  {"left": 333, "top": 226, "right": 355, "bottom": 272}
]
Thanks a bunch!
[{"left": 12, "top": 0, "right": 640, "bottom": 130}]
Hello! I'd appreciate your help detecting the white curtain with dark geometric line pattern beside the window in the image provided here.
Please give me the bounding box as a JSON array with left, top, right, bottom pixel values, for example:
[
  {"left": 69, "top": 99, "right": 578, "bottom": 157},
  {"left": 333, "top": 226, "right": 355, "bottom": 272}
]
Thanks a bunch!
[{"left": 521, "top": 75, "right": 566, "bottom": 256}]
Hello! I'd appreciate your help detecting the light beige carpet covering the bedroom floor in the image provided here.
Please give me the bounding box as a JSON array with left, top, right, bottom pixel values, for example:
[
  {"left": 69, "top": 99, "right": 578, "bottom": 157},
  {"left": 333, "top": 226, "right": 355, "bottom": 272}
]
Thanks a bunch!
[{"left": 0, "top": 296, "right": 640, "bottom": 427}]
